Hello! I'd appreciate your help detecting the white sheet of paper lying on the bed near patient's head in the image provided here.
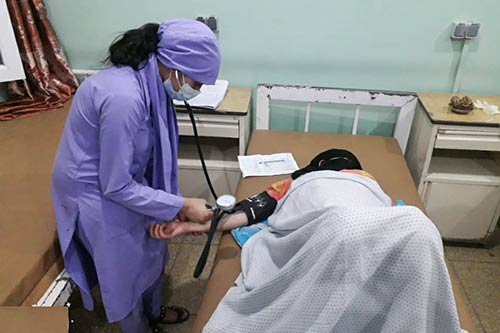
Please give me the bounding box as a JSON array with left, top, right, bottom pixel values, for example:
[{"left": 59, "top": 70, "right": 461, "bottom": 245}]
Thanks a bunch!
[{"left": 238, "top": 153, "right": 299, "bottom": 178}]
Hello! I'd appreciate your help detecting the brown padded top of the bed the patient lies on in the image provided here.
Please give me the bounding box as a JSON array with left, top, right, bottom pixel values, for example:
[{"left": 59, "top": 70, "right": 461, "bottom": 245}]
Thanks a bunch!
[{"left": 193, "top": 131, "right": 475, "bottom": 332}]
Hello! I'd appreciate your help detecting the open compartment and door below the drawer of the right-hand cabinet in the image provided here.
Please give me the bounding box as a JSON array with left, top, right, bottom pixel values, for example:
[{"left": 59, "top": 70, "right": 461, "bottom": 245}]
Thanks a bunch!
[{"left": 422, "top": 150, "right": 500, "bottom": 240}]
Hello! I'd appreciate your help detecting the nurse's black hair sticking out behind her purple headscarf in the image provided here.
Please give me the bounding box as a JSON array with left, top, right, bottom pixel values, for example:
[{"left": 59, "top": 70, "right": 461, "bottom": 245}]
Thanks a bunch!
[{"left": 104, "top": 23, "right": 160, "bottom": 71}]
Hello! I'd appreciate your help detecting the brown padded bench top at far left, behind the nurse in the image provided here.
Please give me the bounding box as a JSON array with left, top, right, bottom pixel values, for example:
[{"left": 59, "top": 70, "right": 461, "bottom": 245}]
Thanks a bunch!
[{"left": 0, "top": 102, "right": 71, "bottom": 306}]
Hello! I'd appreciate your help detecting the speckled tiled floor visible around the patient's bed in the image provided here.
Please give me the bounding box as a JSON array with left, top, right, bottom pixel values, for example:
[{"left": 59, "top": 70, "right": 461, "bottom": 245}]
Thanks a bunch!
[{"left": 70, "top": 229, "right": 500, "bottom": 333}]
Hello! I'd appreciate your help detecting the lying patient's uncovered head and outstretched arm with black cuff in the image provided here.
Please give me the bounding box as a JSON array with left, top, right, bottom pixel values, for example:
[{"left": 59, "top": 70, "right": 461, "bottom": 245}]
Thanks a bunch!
[{"left": 146, "top": 149, "right": 375, "bottom": 239}]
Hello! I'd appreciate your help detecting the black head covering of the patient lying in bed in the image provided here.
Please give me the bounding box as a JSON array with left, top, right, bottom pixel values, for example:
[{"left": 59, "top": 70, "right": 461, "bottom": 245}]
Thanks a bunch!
[{"left": 292, "top": 149, "right": 363, "bottom": 179}]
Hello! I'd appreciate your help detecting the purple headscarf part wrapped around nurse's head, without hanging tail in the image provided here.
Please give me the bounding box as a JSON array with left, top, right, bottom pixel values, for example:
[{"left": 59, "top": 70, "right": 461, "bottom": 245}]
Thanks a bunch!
[{"left": 157, "top": 19, "right": 220, "bottom": 84}]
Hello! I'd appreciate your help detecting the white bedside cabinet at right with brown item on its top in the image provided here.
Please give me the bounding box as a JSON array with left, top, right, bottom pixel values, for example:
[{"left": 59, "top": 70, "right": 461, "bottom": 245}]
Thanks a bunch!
[{"left": 406, "top": 94, "right": 500, "bottom": 243}]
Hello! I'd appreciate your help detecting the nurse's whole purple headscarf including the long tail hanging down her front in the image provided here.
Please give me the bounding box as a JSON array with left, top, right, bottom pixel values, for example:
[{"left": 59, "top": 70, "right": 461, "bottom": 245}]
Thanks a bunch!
[{"left": 139, "top": 19, "right": 221, "bottom": 189}]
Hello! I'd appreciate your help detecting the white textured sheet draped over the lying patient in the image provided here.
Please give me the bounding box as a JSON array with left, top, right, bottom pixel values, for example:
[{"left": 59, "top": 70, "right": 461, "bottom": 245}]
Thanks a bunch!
[{"left": 204, "top": 171, "right": 461, "bottom": 333}]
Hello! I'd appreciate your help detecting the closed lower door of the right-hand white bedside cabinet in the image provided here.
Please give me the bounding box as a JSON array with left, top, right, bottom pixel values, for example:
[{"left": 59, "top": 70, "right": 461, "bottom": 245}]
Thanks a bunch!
[{"left": 424, "top": 181, "right": 500, "bottom": 241}]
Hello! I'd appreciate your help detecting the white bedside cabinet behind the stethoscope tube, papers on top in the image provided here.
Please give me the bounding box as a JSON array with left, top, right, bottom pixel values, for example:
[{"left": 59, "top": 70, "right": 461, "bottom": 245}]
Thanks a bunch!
[{"left": 177, "top": 88, "right": 252, "bottom": 203}]
